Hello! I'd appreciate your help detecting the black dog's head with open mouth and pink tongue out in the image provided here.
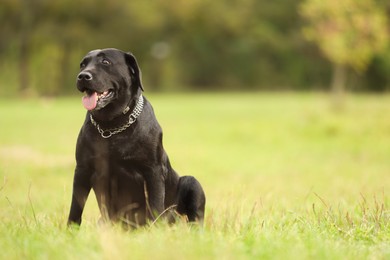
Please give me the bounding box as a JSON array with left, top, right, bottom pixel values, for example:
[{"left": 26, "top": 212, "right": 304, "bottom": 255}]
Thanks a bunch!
[{"left": 77, "top": 49, "right": 143, "bottom": 117}]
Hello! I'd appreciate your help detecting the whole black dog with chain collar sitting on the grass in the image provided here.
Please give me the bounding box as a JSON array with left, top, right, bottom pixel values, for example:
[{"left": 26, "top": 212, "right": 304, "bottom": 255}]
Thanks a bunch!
[{"left": 68, "top": 49, "right": 206, "bottom": 226}]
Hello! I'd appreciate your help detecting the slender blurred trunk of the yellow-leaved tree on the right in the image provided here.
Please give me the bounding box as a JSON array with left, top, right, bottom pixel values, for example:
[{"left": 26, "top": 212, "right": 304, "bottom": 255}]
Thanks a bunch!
[{"left": 331, "top": 63, "right": 347, "bottom": 110}]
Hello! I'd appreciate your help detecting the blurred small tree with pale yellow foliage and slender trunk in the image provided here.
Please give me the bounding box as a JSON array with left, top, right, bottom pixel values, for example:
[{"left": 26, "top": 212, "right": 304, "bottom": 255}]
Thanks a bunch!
[{"left": 300, "top": 0, "right": 389, "bottom": 102}]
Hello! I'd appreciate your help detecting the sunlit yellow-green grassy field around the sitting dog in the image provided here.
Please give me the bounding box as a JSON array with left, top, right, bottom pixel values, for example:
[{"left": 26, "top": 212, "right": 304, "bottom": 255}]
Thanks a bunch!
[{"left": 0, "top": 93, "right": 390, "bottom": 259}]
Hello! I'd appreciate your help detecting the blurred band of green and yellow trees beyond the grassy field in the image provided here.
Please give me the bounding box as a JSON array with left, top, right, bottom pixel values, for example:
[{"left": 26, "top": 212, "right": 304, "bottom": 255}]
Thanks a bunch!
[{"left": 0, "top": 0, "right": 390, "bottom": 96}]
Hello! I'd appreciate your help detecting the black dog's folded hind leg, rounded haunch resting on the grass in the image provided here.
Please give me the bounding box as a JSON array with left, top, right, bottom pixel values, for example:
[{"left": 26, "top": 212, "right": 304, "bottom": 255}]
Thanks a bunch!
[{"left": 176, "top": 176, "right": 206, "bottom": 224}]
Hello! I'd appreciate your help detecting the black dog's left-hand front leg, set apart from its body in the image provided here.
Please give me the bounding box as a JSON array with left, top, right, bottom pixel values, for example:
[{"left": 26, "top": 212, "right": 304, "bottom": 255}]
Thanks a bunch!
[{"left": 68, "top": 168, "right": 91, "bottom": 226}]
